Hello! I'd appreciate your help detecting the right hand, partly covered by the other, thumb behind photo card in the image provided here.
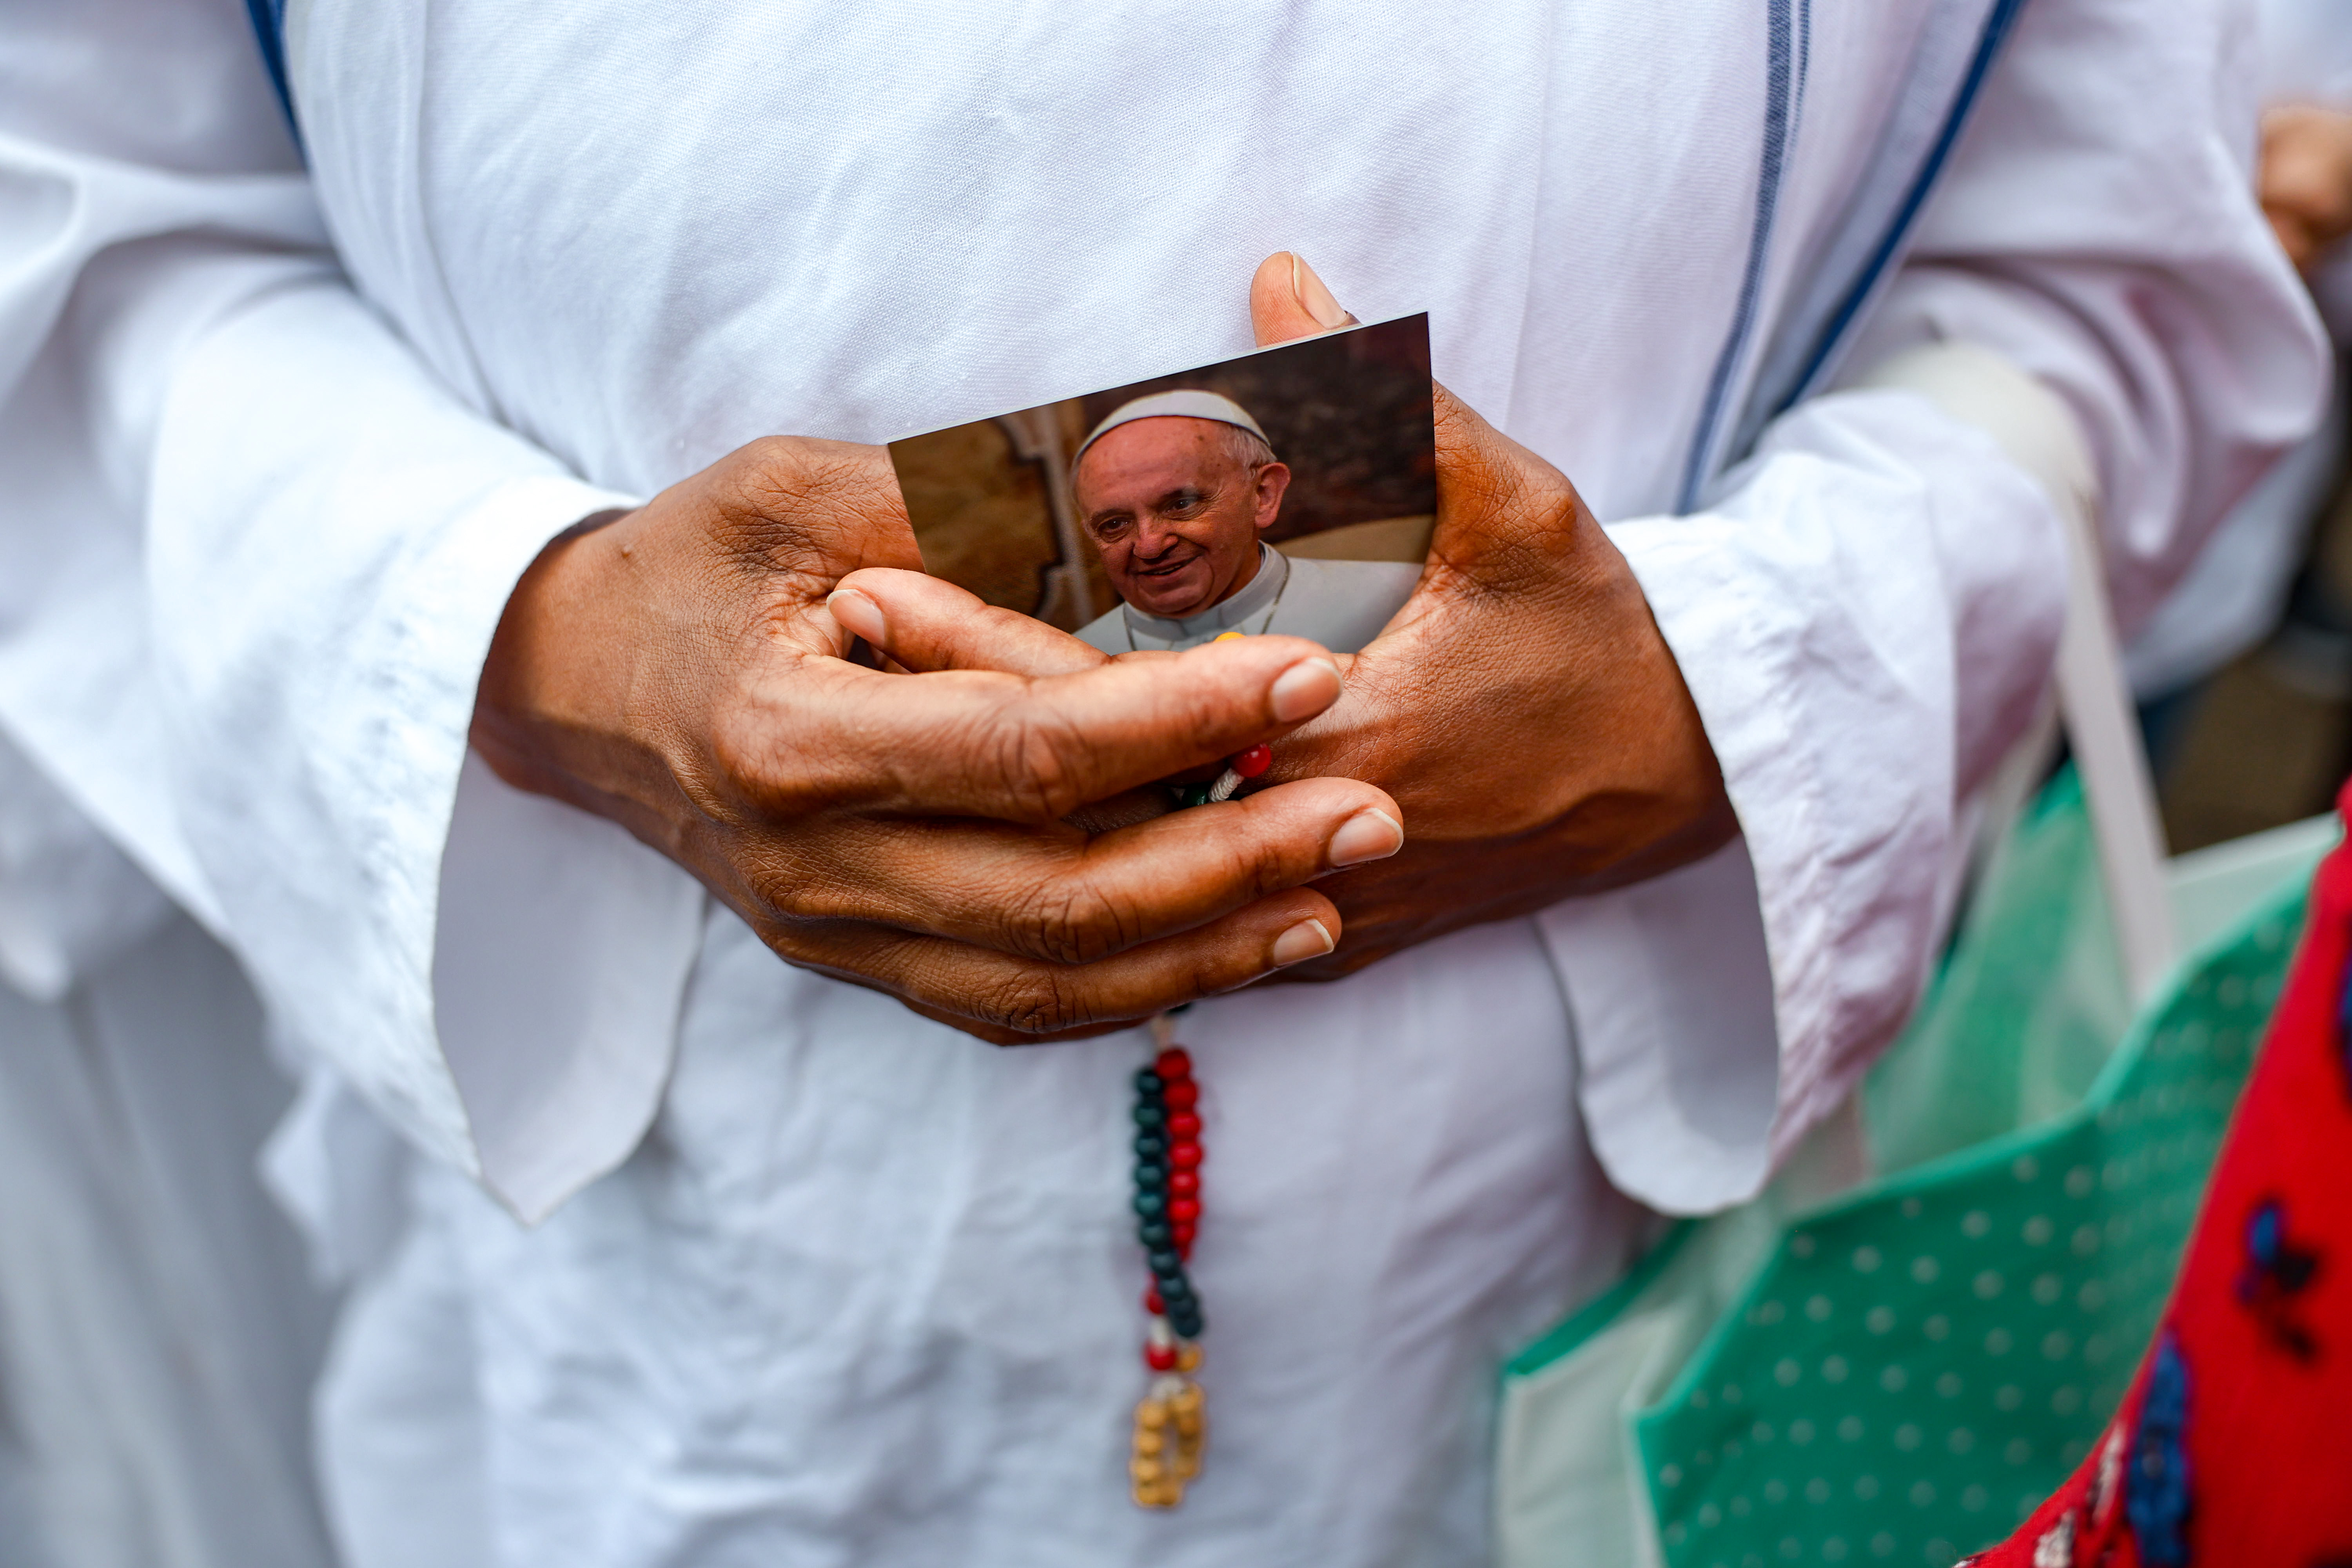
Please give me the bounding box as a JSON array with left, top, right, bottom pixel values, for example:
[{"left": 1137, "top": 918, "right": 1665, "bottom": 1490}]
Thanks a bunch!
[{"left": 844, "top": 254, "right": 1738, "bottom": 980}]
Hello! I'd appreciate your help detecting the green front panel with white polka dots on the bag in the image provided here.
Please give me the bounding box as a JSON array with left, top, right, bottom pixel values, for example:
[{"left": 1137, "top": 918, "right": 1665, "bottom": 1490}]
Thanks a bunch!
[{"left": 1635, "top": 896, "right": 2303, "bottom": 1568}]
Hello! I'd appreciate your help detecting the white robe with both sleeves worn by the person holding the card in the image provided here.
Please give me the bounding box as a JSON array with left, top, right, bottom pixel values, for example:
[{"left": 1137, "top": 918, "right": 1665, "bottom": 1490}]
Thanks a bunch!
[{"left": 0, "top": 0, "right": 2324, "bottom": 1568}]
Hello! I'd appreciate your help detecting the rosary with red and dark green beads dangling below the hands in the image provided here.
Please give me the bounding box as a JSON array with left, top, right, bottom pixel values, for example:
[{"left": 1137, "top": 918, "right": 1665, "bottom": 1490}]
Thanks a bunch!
[{"left": 1127, "top": 724, "right": 1275, "bottom": 1509}]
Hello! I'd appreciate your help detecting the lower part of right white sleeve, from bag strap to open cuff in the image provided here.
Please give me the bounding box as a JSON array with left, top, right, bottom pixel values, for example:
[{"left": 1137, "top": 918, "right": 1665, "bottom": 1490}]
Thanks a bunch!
[{"left": 1571, "top": 390, "right": 2067, "bottom": 1213}]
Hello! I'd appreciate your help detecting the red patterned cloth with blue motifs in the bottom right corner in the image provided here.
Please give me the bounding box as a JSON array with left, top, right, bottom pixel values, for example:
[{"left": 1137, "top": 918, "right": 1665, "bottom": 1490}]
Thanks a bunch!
[{"left": 1971, "top": 785, "right": 2352, "bottom": 1568}]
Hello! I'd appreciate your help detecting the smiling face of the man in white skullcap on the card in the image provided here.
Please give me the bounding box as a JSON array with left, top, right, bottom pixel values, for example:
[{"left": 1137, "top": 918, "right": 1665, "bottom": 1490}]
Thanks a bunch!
[{"left": 1073, "top": 416, "right": 1291, "bottom": 621}]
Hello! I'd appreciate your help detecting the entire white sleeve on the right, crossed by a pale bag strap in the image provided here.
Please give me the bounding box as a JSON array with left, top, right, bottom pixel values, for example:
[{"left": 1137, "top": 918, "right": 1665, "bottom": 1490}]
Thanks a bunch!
[{"left": 1543, "top": 0, "right": 2326, "bottom": 1213}]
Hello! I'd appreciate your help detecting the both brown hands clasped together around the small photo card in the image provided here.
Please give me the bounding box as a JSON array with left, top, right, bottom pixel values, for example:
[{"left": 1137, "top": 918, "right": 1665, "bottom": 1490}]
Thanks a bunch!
[{"left": 480, "top": 255, "right": 1736, "bottom": 1042}]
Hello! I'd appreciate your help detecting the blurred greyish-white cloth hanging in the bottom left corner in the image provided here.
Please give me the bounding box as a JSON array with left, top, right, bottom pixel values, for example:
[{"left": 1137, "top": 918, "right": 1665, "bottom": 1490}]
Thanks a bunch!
[{"left": 0, "top": 917, "right": 332, "bottom": 1568}]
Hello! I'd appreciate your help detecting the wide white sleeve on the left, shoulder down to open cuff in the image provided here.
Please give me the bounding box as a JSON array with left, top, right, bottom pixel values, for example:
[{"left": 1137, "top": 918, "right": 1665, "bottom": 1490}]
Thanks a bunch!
[{"left": 0, "top": 0, "right": 701, "bottom": 1213}]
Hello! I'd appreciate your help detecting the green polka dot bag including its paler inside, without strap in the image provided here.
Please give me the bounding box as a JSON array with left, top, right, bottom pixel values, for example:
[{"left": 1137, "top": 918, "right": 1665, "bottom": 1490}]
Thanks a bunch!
[{"left": 1498, "top": 780, "right": 2317, "bottom": 1568}]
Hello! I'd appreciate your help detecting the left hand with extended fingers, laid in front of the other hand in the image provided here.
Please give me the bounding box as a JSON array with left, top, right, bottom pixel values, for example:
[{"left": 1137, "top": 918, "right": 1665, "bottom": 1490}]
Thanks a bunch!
[{"left": 473, "top": 437, "right": 1404, "bottom": 1042}]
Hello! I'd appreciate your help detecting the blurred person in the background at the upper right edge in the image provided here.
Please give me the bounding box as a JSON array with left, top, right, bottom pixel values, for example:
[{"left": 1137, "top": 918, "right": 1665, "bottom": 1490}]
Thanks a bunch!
[{"left": 2129, "top": 0, "right": 2352, "bottom": 851}]
